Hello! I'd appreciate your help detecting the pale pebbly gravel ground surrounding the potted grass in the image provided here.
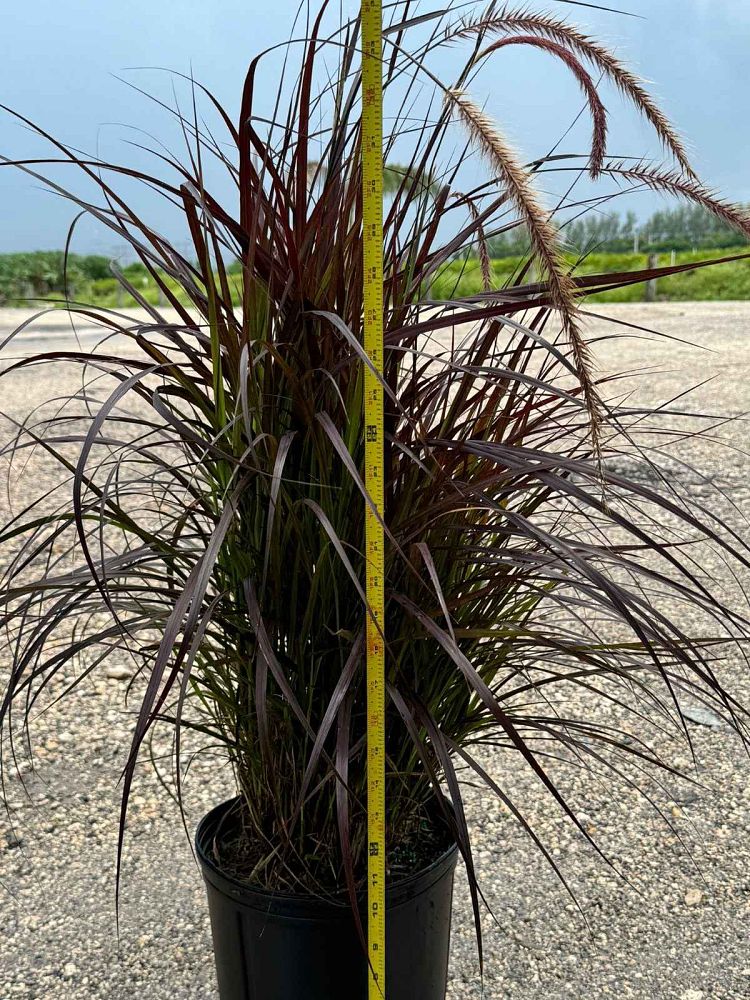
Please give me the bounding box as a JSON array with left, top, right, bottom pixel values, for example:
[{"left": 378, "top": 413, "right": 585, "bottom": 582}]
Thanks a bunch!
[{"left": 0, "top": 303, "right": 750, "bottom": 1000}]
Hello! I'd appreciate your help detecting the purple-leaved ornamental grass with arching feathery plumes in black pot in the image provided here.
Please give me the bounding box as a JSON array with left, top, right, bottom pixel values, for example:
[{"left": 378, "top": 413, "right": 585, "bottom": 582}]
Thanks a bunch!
[{"left": 0, "top": 3, "right": 750, "bottom": 960}]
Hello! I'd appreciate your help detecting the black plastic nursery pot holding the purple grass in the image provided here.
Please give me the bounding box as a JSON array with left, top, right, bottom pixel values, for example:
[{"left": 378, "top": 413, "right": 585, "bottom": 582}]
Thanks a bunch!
[{"left": 195, "top": 799, "right": 458, "bottom": 1000}]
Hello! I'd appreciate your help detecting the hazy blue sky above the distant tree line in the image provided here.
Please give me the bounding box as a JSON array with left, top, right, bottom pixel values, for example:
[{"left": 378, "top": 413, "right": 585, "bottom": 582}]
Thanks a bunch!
[{"left": 0, "top": 0, "right": 750, "bottom": 255}]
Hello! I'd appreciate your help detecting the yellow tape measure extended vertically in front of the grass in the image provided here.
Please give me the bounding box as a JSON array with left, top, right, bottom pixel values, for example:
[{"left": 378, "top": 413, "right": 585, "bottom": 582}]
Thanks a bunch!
[{"left": 362, "top": 0, "right": 386, "bottom": 1000}]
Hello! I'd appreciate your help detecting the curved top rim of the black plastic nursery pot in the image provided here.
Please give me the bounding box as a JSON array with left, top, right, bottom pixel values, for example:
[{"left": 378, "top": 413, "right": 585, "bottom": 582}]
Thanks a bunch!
[{"left": 195, "top": 795, "right": 458, "bottom": 910}]
